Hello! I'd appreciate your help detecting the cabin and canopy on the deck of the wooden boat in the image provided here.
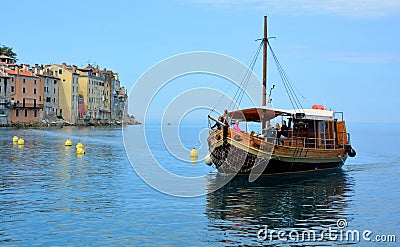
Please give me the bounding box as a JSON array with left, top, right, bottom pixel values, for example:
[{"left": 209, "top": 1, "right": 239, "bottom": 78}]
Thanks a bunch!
[{"left": 228, "top": 107, "right": 349, "bottom": 149}]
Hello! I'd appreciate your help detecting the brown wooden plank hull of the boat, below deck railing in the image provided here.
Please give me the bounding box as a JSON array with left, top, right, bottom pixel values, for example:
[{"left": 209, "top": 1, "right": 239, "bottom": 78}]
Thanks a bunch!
[{"left": 209, "top": 128, "right": 347, "bottom": 174}]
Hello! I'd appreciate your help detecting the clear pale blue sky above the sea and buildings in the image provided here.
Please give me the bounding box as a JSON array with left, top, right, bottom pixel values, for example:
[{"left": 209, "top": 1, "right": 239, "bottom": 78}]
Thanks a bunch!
[{"left": 0, "top": 0, "right": 400, "bottom": 123}]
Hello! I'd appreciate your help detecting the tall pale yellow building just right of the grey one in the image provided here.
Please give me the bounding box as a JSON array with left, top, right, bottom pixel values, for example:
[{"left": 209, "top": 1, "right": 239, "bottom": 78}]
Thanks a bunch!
[{"left": 47, "top": 63, "right": 79, "bottom": 124}]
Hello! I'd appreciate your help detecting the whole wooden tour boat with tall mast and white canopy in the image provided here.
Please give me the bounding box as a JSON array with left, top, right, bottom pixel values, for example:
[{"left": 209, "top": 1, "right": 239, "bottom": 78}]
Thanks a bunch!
[{"left": 208, "top": 17, "right": 356, "bottom": 175}]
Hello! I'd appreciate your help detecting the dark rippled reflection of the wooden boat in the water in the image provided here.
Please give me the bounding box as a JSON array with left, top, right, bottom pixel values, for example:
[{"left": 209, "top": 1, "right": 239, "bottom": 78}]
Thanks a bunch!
[{"left": 206, "top": 170, "right": 353, "bottom": 245}]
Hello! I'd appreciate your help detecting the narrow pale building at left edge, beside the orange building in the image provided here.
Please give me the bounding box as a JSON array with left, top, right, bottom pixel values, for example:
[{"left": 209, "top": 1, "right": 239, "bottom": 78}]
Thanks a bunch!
[{"left": 0, "top": 71, "right": 11, "bottom": 126}]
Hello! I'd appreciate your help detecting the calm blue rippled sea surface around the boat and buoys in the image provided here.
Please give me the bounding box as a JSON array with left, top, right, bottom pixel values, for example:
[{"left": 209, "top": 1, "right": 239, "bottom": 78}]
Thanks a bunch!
[{"left": 0, "top": 124, "right": 400, "bottom": 246}]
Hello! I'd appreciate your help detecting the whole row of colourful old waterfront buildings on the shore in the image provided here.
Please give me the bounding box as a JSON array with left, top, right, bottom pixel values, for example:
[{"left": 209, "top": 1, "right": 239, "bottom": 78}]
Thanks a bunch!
[{"left": 0, "top": 54, "right": 128, "bottom": 125}]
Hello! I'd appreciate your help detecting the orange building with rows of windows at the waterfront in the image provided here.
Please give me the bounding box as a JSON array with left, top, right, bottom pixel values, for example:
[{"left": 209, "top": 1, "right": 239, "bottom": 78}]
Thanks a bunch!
[{"left": 5, "top": 66, "right": 43, "bottom": 123}]
